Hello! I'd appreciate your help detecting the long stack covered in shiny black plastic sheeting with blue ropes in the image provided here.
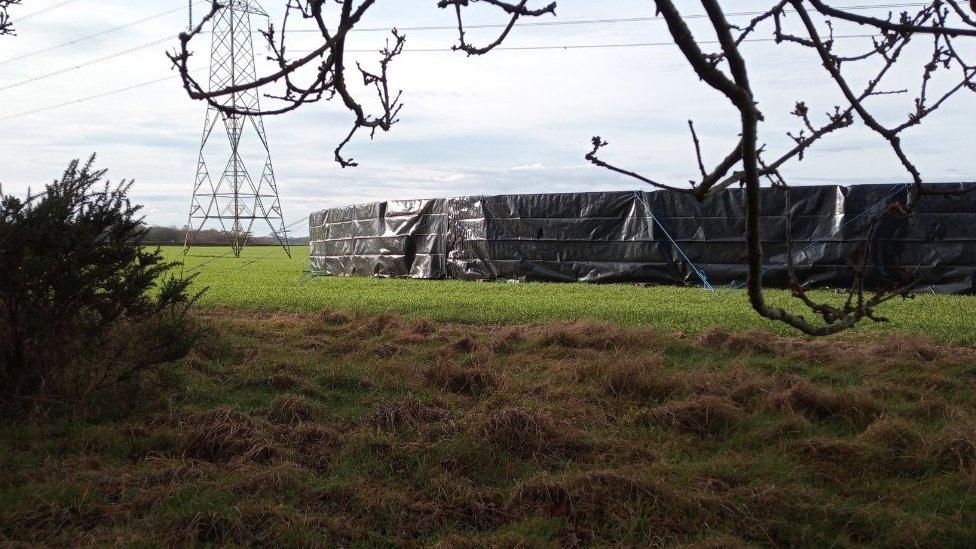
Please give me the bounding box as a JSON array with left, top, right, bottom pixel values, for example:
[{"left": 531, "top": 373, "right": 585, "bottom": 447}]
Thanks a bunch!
[{"left": 309, "top": 184, "right": 976, "bottom": 293}]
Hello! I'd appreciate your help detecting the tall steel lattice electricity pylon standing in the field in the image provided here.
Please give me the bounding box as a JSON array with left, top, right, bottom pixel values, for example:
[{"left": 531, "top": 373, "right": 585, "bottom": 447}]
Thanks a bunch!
[{"left": 184, "top": 0, "right": 291, "bottom": 257}]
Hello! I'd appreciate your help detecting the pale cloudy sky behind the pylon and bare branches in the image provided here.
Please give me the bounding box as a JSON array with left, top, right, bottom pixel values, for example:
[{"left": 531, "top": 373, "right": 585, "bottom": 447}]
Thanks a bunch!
[{"left": 0, "top": 0, "right": 976, "bottom": 233}]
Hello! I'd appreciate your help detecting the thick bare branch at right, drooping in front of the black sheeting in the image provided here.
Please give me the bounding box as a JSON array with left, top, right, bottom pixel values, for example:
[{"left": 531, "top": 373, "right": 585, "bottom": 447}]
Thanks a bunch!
[{"left": 586, "top": 0, "right": 976, "bottom": 335}]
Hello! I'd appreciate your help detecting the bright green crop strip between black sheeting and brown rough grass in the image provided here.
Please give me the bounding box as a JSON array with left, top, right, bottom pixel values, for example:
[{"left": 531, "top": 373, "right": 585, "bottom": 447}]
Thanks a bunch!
[{"left": 164, "top": 247, "right": 976, "bottom": 345}]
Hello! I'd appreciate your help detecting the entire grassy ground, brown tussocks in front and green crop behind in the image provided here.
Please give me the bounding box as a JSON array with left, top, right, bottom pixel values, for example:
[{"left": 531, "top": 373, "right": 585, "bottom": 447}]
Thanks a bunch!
[{"left": 0, "top": 248, "right": 976, "bottom": 547}]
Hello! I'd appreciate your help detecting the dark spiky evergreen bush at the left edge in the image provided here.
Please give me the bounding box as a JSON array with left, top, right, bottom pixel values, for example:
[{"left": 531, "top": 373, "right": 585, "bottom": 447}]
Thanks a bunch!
[{"left": 0, "top": 156, "right": 200, "bottom": 413}]
